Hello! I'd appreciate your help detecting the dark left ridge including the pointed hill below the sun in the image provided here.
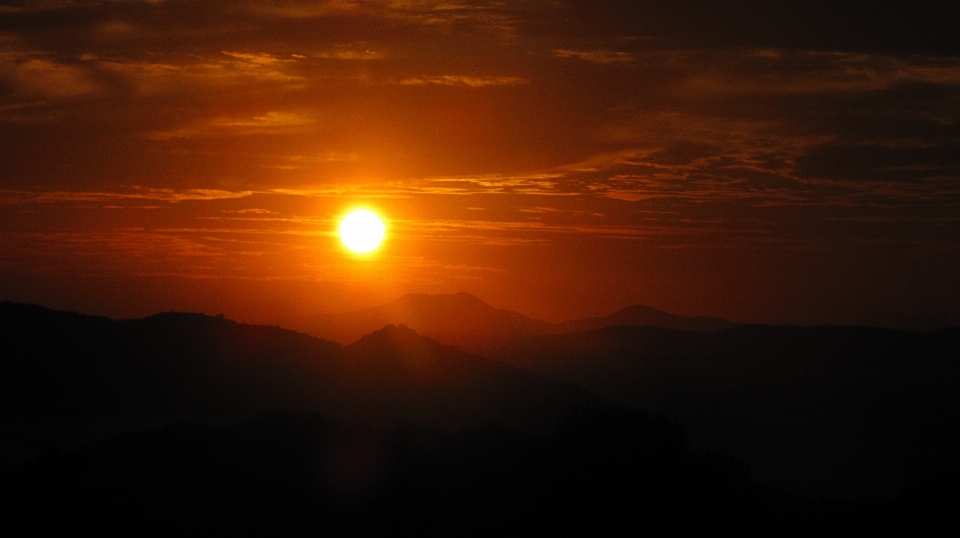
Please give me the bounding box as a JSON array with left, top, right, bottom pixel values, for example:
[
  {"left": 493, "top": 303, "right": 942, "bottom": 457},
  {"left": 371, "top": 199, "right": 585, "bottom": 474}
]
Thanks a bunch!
[{"left": 0, "top": 303, "right": 591, "bottom": 461}]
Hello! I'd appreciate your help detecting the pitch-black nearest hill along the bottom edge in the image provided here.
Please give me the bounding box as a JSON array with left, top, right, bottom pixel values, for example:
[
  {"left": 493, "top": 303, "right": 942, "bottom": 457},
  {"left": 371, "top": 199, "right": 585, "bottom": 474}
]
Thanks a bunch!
[{"left": 0, "top": 406, "right": 928, "bottom": 536}]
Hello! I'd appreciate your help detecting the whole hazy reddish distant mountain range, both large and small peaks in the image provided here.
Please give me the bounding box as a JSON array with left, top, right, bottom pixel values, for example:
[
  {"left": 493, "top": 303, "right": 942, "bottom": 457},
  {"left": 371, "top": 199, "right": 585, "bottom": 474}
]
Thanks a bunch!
[{"left": 296, "top": 292, "right": 735, "bottom": 347}]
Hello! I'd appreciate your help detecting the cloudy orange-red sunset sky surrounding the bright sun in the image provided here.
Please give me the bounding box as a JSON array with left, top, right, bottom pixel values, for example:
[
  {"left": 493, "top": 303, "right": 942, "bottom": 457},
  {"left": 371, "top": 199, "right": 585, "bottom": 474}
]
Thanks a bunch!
[{"left": 0, "top": 0, "right": 960, "bottom": 324}]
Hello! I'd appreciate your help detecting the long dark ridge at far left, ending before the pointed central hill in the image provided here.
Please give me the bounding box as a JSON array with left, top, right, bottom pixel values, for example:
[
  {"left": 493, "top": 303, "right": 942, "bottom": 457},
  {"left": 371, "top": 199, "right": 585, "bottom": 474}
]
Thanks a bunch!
[{"left": 0, "top": 303, "right": 342, "bottom": 420}]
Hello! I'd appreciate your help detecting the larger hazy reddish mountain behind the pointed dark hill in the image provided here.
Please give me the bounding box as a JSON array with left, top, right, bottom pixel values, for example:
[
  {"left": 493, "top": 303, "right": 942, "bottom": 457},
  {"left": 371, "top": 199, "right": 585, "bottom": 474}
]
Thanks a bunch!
[{"left": 297, "top": 293, "right": 550, "bottom": 342}]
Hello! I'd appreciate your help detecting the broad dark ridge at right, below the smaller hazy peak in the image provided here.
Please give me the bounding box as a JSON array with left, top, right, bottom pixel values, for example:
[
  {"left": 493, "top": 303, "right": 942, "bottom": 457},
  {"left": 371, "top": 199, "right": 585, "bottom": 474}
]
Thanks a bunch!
[{"left": 474, "top": 325, "right": 960, "bottom": 498}]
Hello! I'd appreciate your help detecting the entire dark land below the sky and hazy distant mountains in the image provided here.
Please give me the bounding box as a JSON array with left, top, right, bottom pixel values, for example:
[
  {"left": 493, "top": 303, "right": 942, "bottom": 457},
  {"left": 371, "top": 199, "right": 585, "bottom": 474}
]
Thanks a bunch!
[{"left": 0, "top": 303, "right": 960, "bottom": 536}]
